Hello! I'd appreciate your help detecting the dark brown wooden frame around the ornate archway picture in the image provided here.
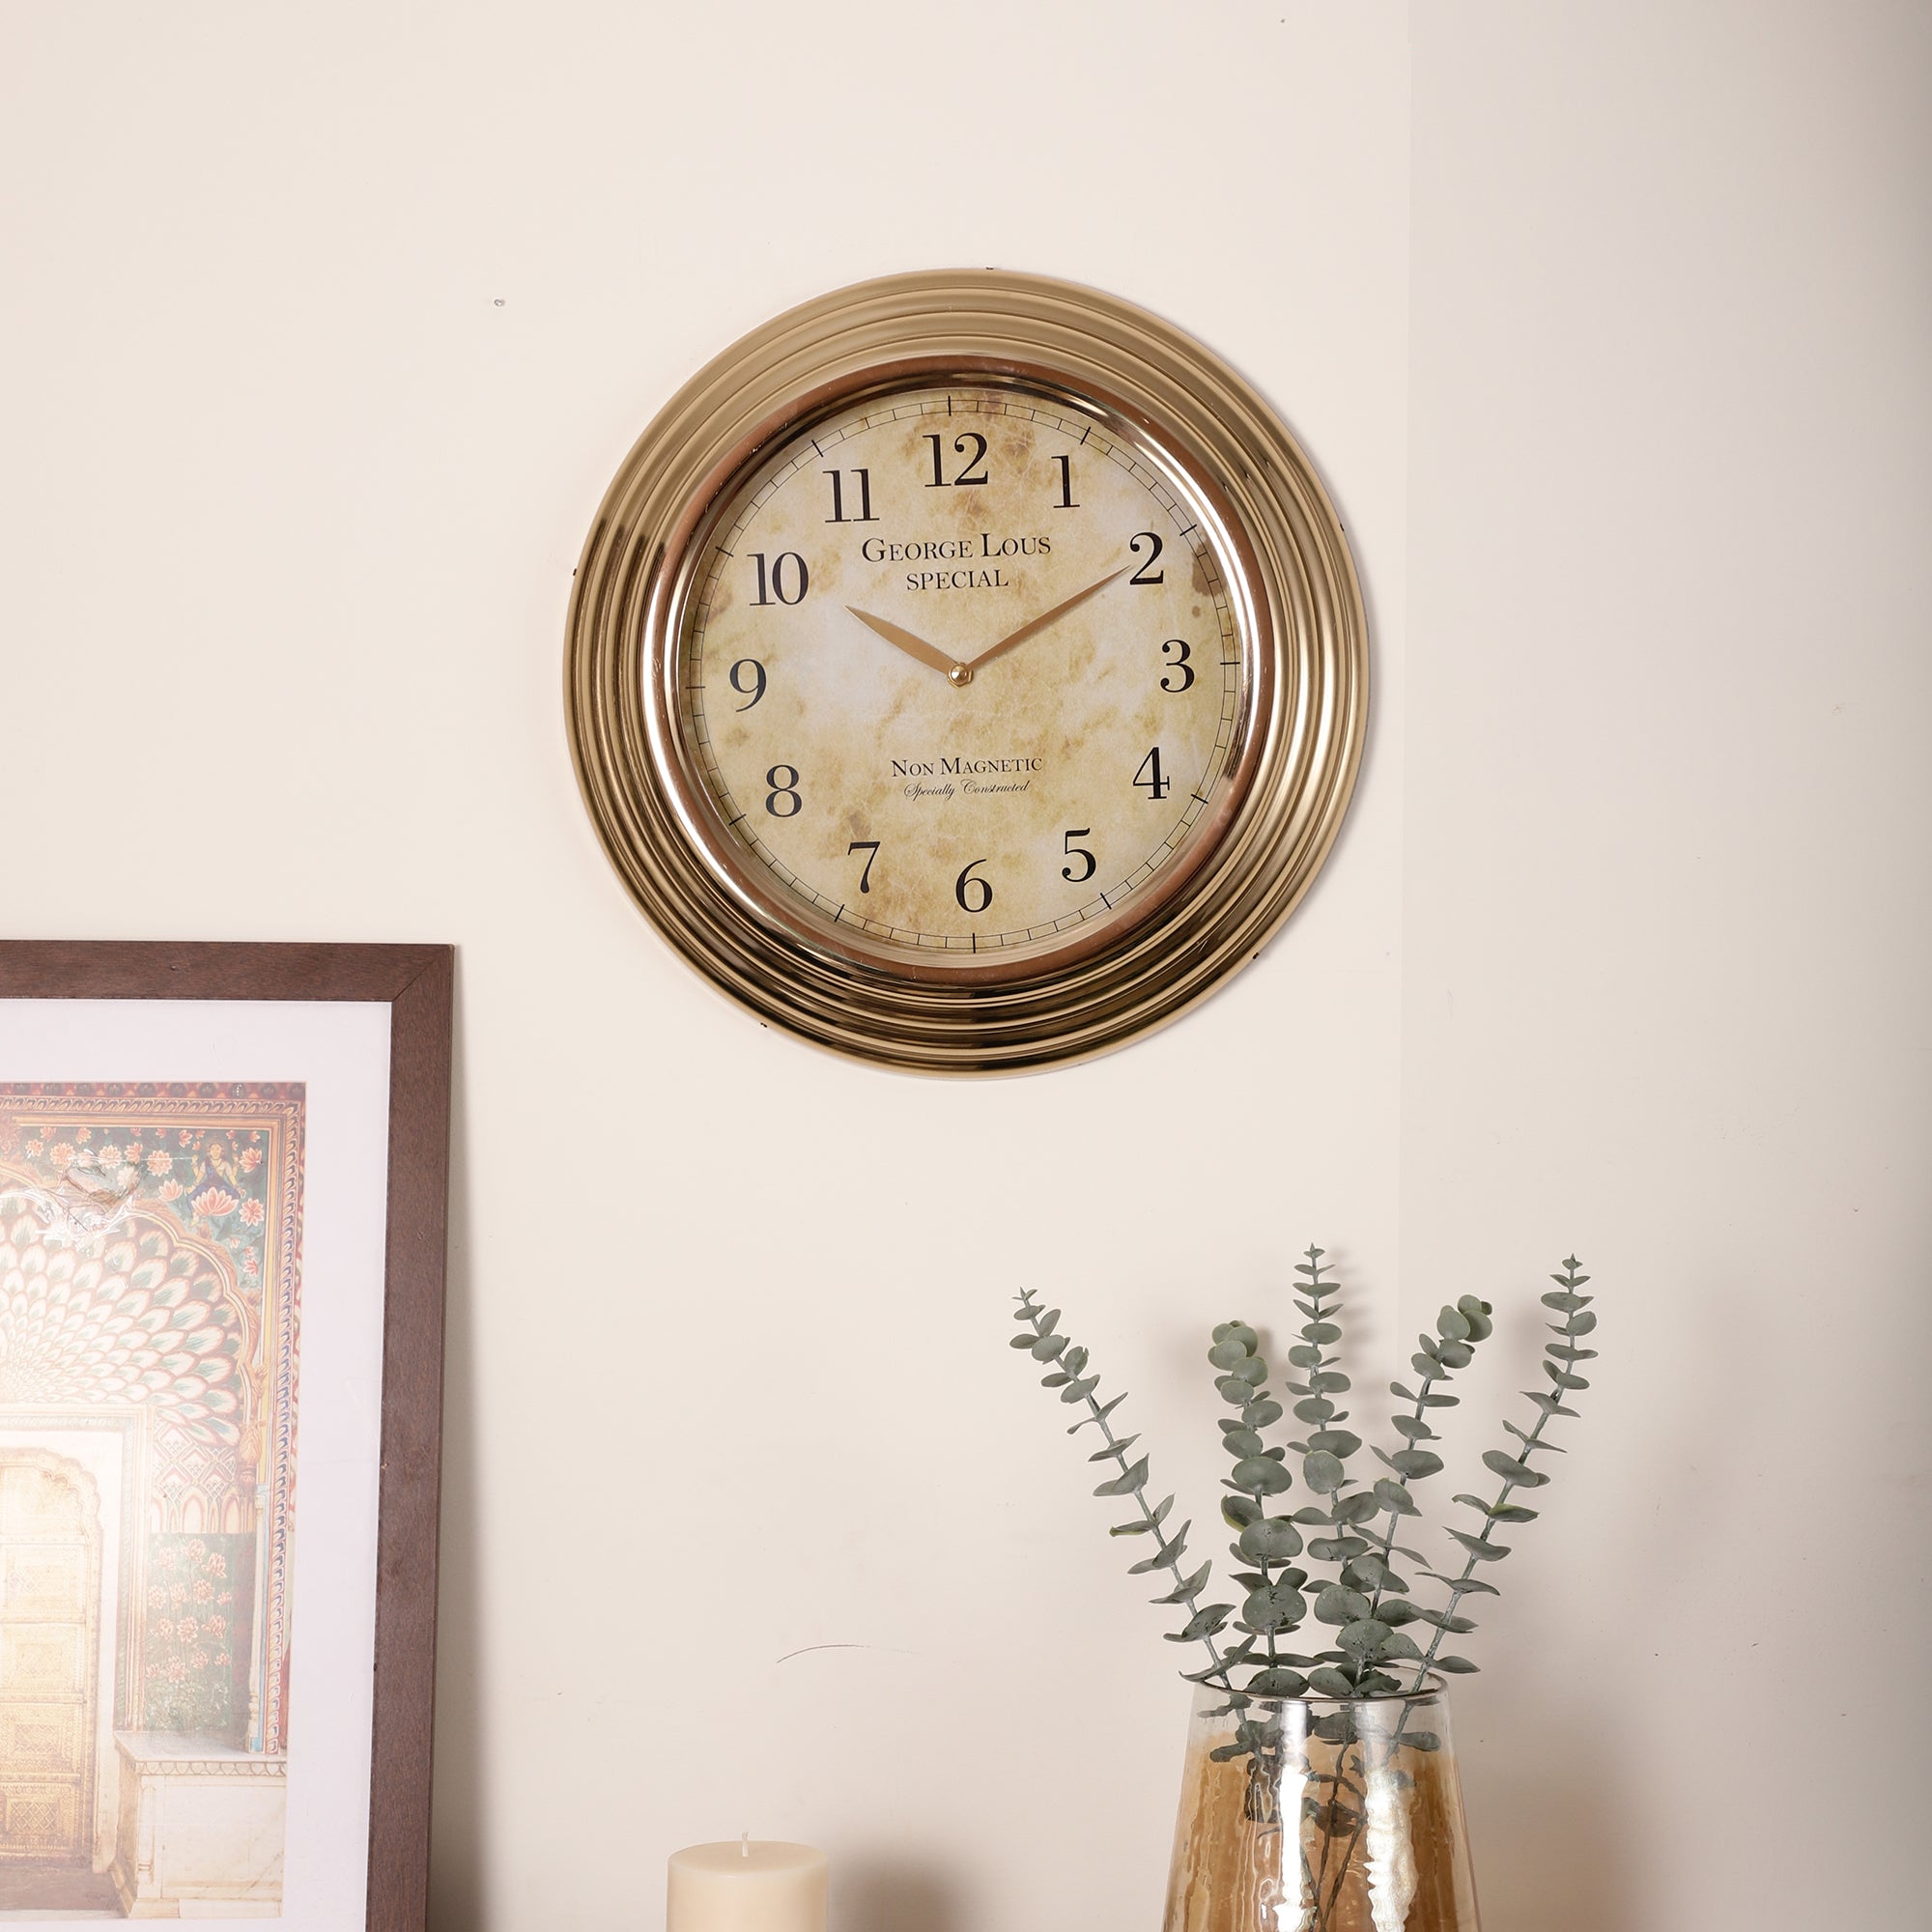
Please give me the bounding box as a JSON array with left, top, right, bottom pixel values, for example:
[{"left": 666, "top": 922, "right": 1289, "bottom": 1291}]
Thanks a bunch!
[{"left": 0, "top": 941, "right": 454, "bottom": 1932}]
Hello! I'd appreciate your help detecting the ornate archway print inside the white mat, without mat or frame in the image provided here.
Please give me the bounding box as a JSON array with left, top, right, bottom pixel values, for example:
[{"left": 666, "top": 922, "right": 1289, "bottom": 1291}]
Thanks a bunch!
[{"left": 0, "top": 1082, "right": 305, "bottom": 1920}]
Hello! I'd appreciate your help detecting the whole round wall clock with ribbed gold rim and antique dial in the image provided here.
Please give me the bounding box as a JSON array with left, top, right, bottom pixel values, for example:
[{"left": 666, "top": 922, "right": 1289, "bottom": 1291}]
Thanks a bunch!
[{"left": 566, "top": 270, "right": 1368, "bottom": 1074}]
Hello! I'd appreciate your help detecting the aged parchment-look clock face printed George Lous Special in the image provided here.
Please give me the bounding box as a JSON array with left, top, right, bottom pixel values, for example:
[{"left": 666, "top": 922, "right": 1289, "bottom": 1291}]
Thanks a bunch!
[{"left": 667, "top": 375, "right": 1254, "bottom": 976}]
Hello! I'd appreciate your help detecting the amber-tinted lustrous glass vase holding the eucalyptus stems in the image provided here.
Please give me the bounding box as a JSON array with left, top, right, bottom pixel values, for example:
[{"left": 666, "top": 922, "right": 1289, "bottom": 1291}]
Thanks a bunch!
[{"left": 1163, "top": 1675, "right": 1478, "bottom": 1932}]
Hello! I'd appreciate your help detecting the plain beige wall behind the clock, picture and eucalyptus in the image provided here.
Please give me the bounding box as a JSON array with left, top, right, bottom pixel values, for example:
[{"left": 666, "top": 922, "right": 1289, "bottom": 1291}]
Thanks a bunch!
[{"left": 0, "top": 0, "right": 1932, "bottom": 1932}]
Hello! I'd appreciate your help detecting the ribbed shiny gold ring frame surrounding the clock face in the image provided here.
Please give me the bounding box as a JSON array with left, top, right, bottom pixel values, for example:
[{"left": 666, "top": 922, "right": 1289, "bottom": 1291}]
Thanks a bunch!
[{"left": 564, "top": 269, "right": 1368, "bottom": 1074}]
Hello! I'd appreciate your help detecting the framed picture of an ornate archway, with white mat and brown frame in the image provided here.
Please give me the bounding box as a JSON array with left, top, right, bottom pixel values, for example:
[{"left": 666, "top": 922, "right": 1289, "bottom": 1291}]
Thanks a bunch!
[{"left": 0, "top": 941, "right": 454, "bottom": 1932}]
